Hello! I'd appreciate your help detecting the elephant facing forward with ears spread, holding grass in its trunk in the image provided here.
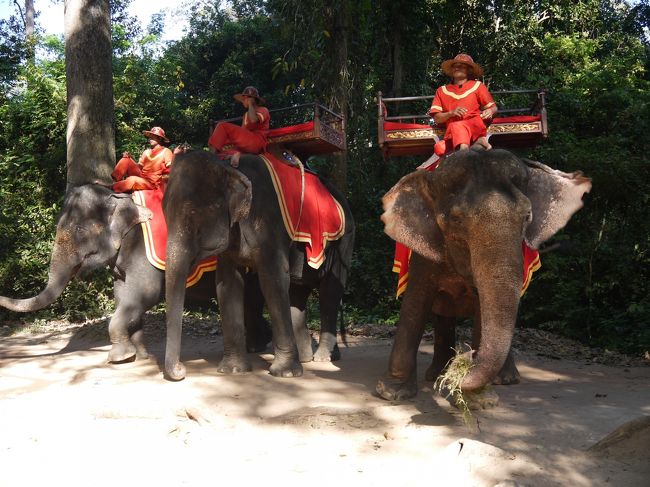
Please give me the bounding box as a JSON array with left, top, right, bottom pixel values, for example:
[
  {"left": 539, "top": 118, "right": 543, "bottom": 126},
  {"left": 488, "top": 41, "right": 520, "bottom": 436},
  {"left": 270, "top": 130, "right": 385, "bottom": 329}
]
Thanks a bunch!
[{"left": 376, "top": 149, "right": 591, "bottom": 400}]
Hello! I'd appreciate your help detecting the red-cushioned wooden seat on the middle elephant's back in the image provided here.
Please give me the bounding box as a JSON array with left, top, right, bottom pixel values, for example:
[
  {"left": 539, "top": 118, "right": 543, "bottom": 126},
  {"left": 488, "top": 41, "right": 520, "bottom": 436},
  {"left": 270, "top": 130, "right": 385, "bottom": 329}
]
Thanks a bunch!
[{"left": 210, "top": 103, "right": 346, "bottom": 159}]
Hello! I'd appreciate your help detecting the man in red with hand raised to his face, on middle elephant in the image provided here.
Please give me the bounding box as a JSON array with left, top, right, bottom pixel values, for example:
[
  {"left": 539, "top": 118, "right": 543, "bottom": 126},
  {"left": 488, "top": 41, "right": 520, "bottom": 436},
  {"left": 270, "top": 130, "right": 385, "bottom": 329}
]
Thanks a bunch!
[{"left": 208, "top": 86, "right": 271, "bottom": 167}]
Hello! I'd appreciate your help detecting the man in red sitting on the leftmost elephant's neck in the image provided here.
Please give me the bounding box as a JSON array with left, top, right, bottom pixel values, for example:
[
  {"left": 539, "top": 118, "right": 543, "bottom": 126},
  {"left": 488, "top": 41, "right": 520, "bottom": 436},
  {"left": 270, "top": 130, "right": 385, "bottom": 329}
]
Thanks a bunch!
[{"left": 111, "top": 127, "right": 174, "bottom": 193}]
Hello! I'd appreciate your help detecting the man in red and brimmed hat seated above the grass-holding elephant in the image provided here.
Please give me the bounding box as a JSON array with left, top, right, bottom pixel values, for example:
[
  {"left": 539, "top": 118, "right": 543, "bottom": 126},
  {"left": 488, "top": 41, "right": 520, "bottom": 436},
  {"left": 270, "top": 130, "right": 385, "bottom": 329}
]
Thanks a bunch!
[{"left": 429, "top": 54, "right": 497, "bottom": 156}]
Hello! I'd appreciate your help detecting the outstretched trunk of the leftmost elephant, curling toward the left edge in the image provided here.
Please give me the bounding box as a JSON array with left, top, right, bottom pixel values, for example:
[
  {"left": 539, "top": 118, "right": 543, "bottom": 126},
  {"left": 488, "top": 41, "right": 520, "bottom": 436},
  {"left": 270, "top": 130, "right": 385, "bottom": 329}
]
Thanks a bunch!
[{"left": 0, "top": 244, "right": 79, "bottom": 313}]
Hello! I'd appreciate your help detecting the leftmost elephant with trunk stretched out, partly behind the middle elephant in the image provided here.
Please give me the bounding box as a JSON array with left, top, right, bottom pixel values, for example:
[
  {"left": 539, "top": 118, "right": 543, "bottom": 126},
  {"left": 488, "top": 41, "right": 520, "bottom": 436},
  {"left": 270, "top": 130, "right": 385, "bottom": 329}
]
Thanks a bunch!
[{"left": 0, "top": 184, "right": 350, "bottom": 363}]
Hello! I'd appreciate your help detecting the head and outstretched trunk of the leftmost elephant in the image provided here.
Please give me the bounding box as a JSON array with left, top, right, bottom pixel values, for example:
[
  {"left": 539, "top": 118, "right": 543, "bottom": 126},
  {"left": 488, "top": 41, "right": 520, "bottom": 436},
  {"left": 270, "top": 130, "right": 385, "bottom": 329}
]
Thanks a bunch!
[{"left": 0, "top": 185, "right": 151, "bottom": 312}]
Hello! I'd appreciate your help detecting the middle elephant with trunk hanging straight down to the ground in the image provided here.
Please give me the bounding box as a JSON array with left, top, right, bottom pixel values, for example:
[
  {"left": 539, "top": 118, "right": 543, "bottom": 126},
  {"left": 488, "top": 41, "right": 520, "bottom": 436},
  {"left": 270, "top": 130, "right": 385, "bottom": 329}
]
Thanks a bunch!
[{"left": 163, "top": 151, "right": 354, "bottom": 380}]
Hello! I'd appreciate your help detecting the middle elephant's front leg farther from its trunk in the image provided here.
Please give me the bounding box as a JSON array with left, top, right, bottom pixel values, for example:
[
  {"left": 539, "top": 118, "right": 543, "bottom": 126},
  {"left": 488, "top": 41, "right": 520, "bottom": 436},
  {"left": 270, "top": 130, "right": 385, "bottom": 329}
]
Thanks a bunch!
[{"left": 258, "top": 264, "right": 302, "bottom": 377}]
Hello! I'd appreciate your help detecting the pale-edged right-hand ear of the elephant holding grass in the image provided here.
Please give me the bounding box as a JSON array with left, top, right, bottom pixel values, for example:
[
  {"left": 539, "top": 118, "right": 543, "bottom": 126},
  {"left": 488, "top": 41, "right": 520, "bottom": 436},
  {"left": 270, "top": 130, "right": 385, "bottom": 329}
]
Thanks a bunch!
[{"left": 522, "top": 159, "right": 591, "bottom": 249}]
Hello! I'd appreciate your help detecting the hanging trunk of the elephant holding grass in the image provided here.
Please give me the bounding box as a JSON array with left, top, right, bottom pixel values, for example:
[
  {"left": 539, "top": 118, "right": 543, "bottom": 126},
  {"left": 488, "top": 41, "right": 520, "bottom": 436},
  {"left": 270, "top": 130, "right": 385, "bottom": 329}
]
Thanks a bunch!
[{"left": 461, "top": 250, "right": 522, "bottom": 392}]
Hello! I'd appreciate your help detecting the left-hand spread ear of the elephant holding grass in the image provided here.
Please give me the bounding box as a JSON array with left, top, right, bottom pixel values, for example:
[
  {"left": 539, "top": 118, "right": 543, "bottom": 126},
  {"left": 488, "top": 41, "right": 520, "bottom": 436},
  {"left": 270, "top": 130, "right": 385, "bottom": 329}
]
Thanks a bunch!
[{"left": 381, "top": 171, "right": 444, "bottom": 262}]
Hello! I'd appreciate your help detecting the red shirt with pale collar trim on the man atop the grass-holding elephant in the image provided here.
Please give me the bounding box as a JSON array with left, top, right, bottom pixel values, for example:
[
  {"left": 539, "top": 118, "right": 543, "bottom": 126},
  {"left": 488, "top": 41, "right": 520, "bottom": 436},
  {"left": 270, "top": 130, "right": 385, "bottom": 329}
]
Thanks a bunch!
[{"left": 429, "top": 80, "right": 495, "bottom": 121}]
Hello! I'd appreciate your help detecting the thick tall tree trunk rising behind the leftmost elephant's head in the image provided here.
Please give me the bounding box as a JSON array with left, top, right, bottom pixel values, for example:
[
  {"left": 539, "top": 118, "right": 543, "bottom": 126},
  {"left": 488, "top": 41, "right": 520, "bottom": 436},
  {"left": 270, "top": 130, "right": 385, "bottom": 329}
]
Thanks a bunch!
[{"left": 65, "top": 0, "right": 115, "bottom": 188}]
